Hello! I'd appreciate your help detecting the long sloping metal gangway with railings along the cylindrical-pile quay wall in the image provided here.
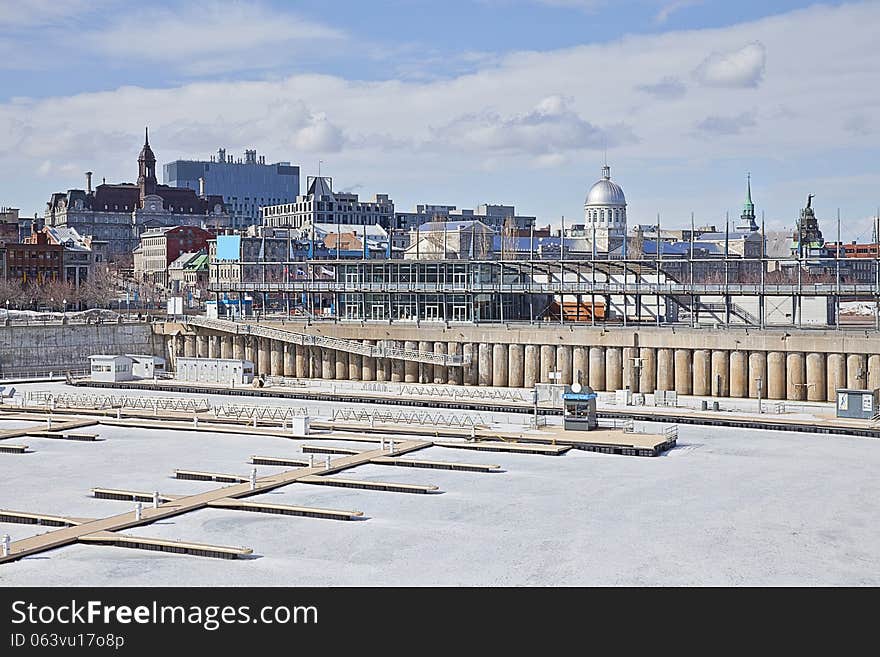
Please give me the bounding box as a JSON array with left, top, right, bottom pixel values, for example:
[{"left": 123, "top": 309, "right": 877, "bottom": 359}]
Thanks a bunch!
[{"left": 181, "top": 315, "right": 470, "bottom": 367}]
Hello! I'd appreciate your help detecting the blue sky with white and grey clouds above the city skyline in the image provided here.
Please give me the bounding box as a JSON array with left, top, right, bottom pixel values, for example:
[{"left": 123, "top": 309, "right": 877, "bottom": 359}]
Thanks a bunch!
[{"left": 0, "top": 0, "right": 880, "bottom": 240}]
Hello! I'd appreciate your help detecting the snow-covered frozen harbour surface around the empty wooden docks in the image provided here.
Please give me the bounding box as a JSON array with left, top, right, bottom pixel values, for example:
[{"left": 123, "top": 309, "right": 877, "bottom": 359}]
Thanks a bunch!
[{"left": 0, "top": 385, "right": 880, "bottom": 586}]
